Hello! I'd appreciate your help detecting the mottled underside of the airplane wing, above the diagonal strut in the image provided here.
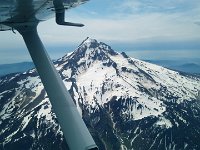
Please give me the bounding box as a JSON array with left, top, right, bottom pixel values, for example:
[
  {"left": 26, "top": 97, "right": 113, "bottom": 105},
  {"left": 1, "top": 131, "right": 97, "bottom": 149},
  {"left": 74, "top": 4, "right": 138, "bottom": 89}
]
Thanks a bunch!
[{"left": 0, "top": 0, "right": 88, "bottom": 31}]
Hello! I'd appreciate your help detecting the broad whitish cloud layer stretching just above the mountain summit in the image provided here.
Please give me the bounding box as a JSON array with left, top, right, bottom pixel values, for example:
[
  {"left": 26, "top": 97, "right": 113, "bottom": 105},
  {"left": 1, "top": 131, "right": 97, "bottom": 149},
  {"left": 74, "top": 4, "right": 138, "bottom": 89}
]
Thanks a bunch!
[{"left": 39, "top": 10, "right": 200, "bottom": 44}]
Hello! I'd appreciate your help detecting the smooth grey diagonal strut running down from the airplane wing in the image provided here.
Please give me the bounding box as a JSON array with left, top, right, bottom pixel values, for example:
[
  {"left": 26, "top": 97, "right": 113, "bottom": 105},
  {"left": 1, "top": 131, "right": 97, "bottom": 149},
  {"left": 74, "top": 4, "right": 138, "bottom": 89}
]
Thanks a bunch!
[{"left": 15, "top": 23, "right": 98, "bottom": 150}]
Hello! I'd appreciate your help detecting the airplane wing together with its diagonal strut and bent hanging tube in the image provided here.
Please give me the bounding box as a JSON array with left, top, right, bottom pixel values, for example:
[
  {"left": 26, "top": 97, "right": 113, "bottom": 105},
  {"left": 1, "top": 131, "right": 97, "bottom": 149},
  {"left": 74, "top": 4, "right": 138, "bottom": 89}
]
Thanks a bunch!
[{"left": 0, "top": 0, "right": 98, "bottom": 150}]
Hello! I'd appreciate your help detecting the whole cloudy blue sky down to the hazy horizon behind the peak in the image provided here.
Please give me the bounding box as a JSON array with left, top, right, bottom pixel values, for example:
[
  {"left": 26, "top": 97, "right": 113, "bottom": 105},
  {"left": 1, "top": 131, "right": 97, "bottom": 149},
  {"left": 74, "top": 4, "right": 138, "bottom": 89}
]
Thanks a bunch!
[{"left": 0, "top": 0, "right": 200, "bottom": 63}]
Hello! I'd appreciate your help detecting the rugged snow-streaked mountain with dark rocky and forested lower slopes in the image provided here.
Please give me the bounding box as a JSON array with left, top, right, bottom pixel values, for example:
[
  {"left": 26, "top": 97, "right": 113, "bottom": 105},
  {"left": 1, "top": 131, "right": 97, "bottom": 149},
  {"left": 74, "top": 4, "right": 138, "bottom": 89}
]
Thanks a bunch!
[{"left": 0, "top": 38, "right": 200, "bottom": 150}]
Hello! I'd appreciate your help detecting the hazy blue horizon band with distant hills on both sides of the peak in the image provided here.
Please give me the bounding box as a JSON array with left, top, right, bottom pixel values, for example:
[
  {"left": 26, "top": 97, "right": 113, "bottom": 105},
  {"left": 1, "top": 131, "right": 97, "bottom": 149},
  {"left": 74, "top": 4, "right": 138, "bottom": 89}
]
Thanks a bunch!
[{"left": 0, "top": 45, "right": 200, "bottom": 64}]
